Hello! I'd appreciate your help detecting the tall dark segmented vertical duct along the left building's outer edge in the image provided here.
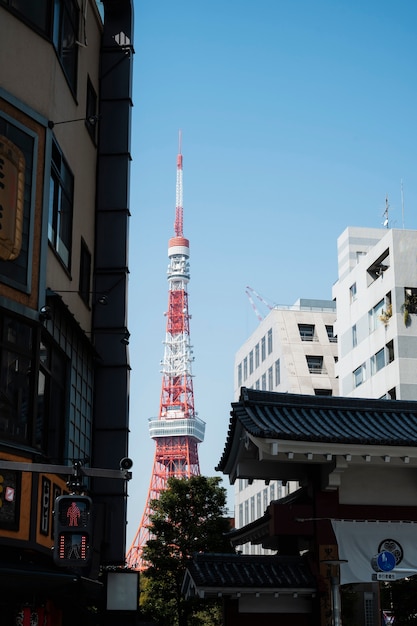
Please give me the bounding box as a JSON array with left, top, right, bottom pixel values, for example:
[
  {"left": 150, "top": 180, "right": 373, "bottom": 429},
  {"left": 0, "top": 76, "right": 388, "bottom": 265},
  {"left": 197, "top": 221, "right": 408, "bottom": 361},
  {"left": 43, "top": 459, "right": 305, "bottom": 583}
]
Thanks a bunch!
[{"left": 91, "top": 0, "right": 134, "bottom": 565}]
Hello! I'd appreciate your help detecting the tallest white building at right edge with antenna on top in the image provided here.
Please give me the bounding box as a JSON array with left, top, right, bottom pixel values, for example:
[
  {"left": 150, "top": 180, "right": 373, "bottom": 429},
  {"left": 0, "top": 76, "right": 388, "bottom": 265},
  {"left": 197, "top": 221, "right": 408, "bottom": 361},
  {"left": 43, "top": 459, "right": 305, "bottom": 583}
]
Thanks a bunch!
[{"left": 332, "top": 227, "right": 417, "bottom": 400}]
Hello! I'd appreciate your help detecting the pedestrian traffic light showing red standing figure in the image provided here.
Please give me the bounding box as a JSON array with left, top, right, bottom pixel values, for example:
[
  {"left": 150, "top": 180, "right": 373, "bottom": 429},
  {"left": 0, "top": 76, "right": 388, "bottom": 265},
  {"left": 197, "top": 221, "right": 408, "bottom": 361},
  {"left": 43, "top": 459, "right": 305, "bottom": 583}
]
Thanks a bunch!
[{"left": 53, "top": 495, "right": 93, "bottom": 567}]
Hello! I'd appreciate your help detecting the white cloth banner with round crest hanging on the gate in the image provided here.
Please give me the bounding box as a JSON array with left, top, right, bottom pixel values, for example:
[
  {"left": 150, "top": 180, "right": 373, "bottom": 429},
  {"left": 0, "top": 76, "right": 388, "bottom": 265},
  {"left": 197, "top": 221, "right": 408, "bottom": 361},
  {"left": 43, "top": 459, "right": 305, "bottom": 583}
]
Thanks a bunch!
[{"left": 332, "top": 520, "right": 417, "bottom": 585}]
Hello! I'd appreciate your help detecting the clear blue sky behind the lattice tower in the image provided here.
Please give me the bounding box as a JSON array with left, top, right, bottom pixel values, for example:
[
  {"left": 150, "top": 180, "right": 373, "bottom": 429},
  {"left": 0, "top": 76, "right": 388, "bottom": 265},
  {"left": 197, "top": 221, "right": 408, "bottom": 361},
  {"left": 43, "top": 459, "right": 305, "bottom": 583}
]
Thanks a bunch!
[{"left": 128, "top": 0, "right": 417, "bottom": 545}]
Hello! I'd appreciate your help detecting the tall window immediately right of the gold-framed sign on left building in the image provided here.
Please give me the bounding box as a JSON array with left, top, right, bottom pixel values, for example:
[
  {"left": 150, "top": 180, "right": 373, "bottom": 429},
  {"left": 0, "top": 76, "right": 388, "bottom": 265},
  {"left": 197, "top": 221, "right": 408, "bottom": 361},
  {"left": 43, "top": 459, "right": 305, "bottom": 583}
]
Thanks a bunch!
[{"left": 48, "top": 141, "right": 74, "bottom": 269}]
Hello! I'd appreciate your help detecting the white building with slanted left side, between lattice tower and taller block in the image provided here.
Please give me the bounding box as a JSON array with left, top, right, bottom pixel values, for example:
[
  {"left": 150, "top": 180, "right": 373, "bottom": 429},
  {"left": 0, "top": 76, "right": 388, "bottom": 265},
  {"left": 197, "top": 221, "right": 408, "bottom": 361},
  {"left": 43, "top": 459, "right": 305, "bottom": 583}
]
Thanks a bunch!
[{"left": 234, "top": 299, "right": 338, "bottom": 554}]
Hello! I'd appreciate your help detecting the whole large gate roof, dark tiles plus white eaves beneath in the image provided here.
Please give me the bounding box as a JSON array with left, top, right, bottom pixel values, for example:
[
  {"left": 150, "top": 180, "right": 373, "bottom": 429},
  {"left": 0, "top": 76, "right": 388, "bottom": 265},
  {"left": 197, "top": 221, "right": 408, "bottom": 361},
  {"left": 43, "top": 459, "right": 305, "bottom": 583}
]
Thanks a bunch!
[{"left": 216, "top": 387, "right": 417, "bottom": 483}]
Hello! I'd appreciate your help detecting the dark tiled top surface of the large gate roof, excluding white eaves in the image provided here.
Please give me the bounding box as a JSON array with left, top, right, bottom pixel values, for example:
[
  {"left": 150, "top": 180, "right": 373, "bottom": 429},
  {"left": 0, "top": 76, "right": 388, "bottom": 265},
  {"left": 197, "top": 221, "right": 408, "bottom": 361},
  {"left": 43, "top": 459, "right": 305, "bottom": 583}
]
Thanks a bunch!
[{"left": 216, "top": 387, "right": 417, "bottom": 471}]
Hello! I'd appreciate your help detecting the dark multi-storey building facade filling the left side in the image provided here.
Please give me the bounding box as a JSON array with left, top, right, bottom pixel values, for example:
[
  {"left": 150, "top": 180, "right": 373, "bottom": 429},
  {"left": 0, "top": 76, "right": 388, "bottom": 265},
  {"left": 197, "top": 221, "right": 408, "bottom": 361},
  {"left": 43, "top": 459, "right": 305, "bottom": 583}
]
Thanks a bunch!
[{"left": 0, "top": 0, "right": 133, "bottom": 626}]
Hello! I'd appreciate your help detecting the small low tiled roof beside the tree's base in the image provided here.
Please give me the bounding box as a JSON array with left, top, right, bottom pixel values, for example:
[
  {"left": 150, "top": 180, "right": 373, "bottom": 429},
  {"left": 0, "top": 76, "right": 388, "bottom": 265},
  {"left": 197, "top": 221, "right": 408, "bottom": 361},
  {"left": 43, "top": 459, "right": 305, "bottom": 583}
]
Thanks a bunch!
[{"left": 184, "top": 554, "right": 316, "bottom": 591}]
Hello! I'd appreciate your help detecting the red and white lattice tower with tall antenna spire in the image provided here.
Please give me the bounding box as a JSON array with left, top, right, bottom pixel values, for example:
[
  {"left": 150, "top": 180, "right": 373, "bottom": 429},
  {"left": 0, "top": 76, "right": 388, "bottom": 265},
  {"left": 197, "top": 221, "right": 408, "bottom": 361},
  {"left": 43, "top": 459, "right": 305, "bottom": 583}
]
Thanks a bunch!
[{"left": 126, "top": 132, "right": 205, "bottom": 570}]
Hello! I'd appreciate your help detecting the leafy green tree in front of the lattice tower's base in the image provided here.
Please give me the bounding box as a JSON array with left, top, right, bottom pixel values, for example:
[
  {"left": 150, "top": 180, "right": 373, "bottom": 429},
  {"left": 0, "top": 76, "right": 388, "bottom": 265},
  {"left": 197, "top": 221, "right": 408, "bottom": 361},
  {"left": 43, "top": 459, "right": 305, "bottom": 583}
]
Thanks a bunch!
[{"left": 141, "top": 476, "right": 233, "bottom": 626}]
